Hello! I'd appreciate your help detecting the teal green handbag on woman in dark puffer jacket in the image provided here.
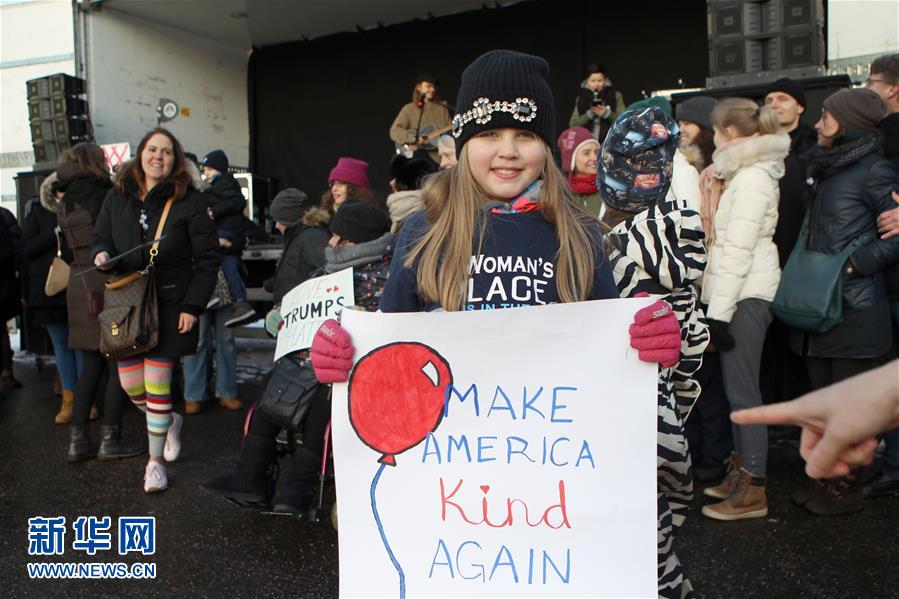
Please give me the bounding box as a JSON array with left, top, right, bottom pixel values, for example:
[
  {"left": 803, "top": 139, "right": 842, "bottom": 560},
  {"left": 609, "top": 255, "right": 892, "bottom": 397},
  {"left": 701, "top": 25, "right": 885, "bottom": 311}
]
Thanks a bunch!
[{"left": 771, "top": 215, "right": 876, "bottom": 333}]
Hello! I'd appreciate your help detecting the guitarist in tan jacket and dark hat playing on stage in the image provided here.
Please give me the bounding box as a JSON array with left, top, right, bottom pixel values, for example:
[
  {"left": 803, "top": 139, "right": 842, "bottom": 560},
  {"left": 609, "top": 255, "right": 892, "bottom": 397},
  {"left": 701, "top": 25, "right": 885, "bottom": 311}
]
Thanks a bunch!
[{"left": 390, "top": 73, "right": 450, "bottom": 162}]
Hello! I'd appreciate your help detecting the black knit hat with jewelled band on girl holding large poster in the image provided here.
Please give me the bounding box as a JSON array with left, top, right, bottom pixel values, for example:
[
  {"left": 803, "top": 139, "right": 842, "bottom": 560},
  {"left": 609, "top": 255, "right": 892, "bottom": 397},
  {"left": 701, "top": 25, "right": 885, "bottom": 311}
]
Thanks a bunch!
[{"left": 453, "top": 50, "right": 556, "bottom": 157}]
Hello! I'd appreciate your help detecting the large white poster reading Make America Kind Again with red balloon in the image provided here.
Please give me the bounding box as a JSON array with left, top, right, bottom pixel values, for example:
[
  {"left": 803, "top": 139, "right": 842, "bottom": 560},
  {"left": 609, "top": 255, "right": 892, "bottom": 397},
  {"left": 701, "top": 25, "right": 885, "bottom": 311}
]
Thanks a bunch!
[{"left": 332, "top": 299, "right": 658, "bottom": 597}]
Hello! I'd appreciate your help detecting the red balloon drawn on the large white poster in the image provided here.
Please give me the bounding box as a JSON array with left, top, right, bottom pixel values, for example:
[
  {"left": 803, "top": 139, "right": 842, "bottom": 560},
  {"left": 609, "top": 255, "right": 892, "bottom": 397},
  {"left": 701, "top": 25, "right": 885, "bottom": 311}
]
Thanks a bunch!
[{"left": 348, "top": 342, "right": 453, "bottom": 466}]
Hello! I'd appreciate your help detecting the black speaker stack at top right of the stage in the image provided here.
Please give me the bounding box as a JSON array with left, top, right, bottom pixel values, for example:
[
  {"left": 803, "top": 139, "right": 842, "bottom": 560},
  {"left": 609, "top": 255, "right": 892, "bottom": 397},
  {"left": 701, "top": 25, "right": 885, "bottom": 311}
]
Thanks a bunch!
[{"left": 706, "top": 0, "right": 825, "bottom": 88}]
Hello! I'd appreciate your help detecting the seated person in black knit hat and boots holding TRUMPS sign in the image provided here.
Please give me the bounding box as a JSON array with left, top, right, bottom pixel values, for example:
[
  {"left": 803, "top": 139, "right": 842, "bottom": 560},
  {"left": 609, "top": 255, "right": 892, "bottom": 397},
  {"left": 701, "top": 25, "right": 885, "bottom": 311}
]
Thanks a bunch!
[{"left": 201, "top": 200, "right": 394, "bottom": 514}]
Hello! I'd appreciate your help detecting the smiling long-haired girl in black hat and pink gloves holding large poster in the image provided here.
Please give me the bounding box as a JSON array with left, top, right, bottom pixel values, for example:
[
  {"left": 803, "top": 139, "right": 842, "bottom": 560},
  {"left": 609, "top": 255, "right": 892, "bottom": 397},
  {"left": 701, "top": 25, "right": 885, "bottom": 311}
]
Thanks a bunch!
[{"left": 311, "top": 50, "right": 681, "bottom": 595}]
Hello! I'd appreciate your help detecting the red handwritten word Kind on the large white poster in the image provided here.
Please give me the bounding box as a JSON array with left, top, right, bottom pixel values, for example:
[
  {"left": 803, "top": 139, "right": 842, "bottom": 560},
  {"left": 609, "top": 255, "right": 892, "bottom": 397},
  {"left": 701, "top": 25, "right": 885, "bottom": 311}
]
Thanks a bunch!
[{"left": 440, "top": 477, "right": 571, "bottom": 529}]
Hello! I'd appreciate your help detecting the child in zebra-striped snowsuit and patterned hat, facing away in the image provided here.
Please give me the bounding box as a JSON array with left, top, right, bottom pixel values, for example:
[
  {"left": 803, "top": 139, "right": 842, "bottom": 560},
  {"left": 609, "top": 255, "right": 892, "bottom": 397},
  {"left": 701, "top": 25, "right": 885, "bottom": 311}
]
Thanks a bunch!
[{"left": 598, "top": 106, "right": 709, "bottom": 597}]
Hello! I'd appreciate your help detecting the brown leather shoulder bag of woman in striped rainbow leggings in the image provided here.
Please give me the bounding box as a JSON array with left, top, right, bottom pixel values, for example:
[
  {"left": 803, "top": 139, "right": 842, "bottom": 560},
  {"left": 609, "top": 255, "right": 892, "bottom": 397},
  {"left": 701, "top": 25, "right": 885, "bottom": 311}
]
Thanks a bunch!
[{"left": 98, "top": 198, "right": 174, "bottom": 360}]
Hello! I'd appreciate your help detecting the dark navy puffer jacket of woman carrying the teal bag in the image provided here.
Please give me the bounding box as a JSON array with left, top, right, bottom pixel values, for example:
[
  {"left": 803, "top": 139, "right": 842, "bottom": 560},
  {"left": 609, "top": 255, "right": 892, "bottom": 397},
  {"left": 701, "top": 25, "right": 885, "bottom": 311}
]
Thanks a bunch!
[{"left": 790, "top": 132, "right": 899, "bottom": 358}]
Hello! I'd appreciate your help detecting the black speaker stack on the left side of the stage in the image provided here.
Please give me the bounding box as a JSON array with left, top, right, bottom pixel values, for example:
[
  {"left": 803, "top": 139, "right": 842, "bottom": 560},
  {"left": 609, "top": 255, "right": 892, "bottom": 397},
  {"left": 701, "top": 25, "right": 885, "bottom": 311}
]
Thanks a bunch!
[{"left": 26, "top": 73, "right": 94, "bottom": 169}]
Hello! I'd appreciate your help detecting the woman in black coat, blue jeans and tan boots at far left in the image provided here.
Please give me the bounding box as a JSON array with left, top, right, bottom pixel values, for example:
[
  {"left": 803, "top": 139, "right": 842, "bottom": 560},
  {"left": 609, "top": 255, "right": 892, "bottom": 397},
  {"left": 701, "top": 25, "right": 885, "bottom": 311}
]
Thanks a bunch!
[{"left": 22, "top": 183, "right": 78, "bottom": 424}]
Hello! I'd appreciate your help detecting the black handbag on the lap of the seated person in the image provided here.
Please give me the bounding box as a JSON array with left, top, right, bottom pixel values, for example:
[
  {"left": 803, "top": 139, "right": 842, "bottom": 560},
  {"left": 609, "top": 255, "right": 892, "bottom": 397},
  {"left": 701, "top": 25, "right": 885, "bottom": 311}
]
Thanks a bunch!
[{"left": 257, "top": 356, "right": 325, "bottom": 431}]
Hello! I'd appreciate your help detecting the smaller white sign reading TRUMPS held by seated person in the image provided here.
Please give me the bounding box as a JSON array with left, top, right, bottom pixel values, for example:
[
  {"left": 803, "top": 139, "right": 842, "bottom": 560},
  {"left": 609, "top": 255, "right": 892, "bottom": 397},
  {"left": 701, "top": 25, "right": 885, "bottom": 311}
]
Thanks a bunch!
[{"left": 275, "top": 268, "right": 356, "bottom": 360}]
